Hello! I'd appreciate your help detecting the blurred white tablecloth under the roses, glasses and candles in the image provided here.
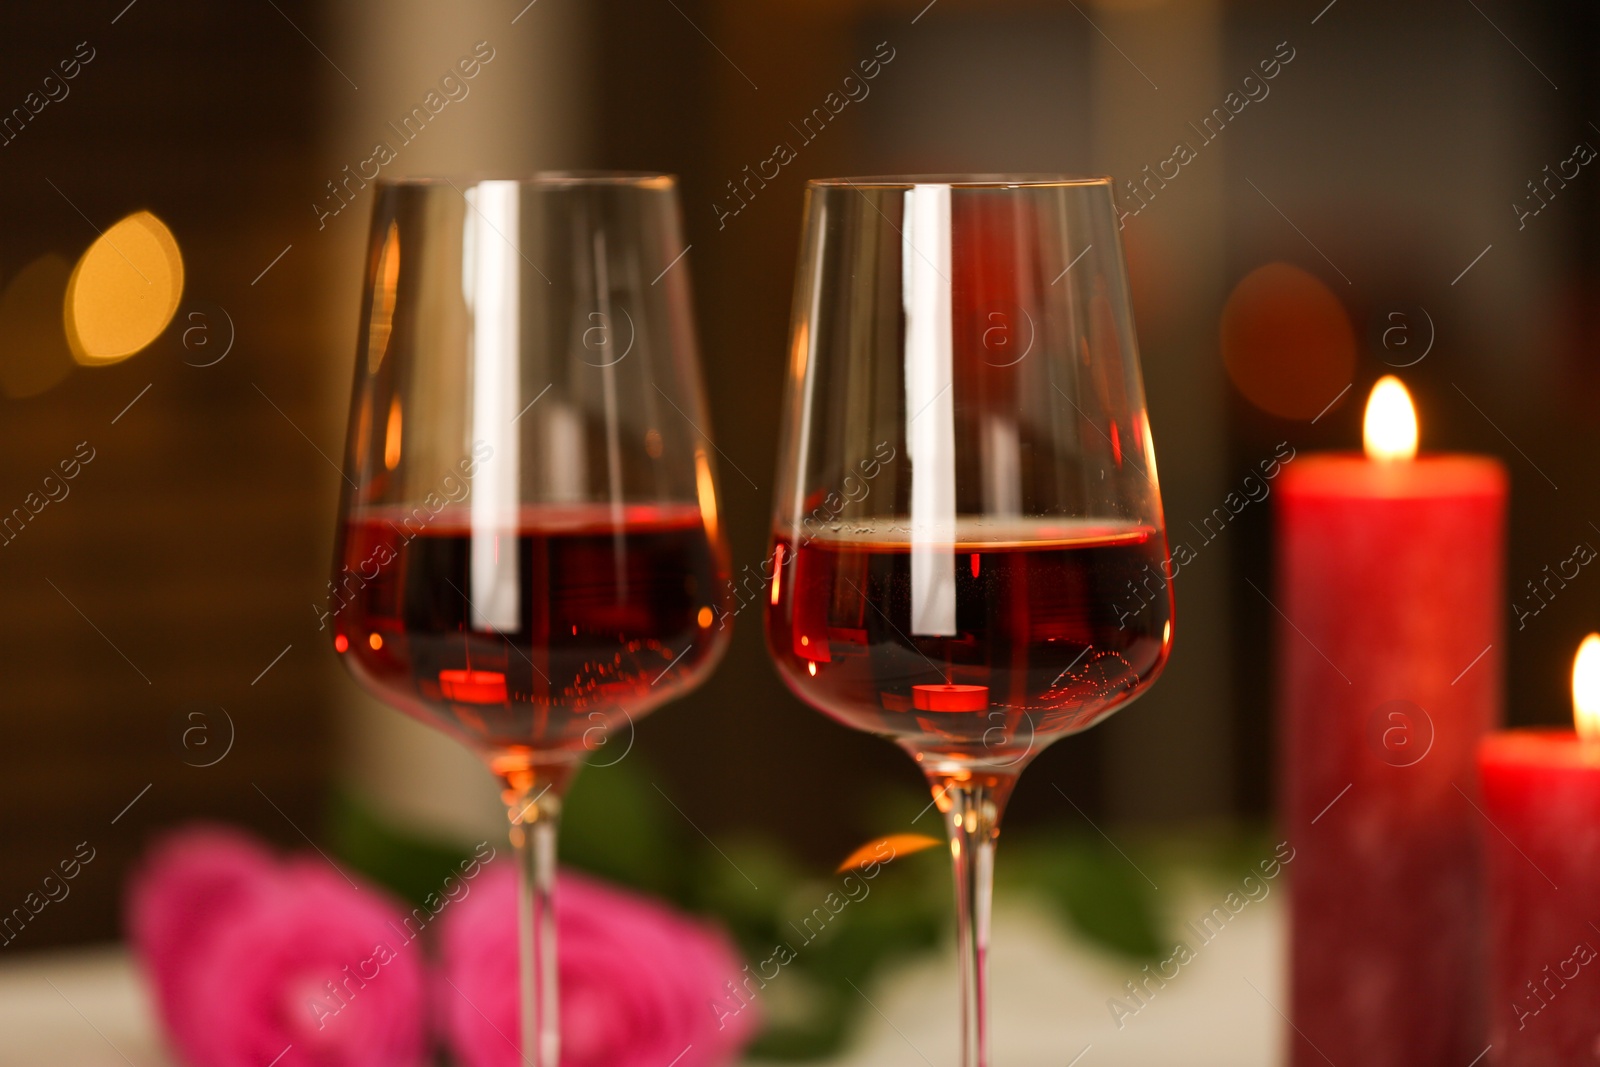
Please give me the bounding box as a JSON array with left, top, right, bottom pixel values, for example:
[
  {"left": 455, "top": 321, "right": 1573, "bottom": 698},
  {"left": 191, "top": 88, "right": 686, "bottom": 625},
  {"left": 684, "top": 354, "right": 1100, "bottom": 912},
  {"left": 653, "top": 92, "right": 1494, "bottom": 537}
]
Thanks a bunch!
[{"left": 0, "top": 885, "right": 1286, "bottom": 1067}]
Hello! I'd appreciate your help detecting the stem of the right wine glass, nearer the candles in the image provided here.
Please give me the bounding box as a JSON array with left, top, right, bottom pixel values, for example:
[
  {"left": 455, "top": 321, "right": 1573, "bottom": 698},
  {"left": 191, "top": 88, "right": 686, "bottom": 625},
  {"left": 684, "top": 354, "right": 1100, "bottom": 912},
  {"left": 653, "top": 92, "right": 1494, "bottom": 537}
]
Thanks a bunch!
[{"left": 934, "top": 776, "right": 1013, "bottom": 1067}]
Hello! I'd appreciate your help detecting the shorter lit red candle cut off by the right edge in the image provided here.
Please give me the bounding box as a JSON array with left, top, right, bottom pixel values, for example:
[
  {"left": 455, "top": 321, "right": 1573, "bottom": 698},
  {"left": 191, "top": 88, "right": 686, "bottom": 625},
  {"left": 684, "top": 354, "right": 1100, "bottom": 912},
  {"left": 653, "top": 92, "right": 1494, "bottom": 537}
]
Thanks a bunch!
[{"left": 1478, "top": 635, "right": 1600, "bottom": 1067}]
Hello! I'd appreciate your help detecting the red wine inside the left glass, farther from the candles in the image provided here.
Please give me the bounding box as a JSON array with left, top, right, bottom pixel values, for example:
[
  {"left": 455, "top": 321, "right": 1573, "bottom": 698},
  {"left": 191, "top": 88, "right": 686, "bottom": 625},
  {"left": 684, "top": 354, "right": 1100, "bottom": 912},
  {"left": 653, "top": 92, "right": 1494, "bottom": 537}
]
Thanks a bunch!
[{"left": 330, "top": 504, "right": 728, "bottom": 757}]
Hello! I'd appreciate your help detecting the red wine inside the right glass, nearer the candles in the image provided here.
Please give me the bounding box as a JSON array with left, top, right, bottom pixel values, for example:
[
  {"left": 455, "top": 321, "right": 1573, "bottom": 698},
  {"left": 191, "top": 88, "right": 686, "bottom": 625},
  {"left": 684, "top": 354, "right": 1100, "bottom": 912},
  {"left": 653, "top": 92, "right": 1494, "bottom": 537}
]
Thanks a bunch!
[{"left": 766, "top": 520, "right": 1173, "bottom": 765}]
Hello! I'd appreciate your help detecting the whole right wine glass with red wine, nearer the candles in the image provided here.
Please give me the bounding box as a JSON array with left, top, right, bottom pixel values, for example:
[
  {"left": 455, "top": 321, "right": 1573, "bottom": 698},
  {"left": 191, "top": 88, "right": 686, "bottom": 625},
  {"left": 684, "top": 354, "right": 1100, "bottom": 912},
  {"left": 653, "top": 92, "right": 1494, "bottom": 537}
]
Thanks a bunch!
[{"left": 766, "top": 174, "right": 1173, "bottom": 1067}]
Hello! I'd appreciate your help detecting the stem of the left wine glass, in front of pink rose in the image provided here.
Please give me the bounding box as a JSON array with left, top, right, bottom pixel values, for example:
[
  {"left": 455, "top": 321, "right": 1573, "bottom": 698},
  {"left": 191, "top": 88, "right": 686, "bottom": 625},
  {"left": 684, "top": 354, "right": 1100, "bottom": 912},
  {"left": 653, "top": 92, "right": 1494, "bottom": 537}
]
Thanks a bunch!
[{"left": 507, "top": 781, "right": 562, "bottom": 1067}]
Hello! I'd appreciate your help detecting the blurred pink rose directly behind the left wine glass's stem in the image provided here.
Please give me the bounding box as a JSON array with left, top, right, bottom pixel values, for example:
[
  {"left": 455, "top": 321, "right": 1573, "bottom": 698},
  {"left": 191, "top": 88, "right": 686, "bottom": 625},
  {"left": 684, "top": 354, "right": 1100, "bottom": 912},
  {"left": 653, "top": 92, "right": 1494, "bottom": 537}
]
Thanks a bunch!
[{"left": 435, "top": 867, "right": 757, "bottom": 1067}]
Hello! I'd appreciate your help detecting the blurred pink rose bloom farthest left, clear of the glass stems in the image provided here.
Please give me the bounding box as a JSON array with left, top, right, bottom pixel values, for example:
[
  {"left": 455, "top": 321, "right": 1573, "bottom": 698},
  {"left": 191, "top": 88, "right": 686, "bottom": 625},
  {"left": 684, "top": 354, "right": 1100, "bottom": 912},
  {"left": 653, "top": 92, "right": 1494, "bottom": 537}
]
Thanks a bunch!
[{"left": 130, "top": 830, "right": 427, "bottom": 1067}]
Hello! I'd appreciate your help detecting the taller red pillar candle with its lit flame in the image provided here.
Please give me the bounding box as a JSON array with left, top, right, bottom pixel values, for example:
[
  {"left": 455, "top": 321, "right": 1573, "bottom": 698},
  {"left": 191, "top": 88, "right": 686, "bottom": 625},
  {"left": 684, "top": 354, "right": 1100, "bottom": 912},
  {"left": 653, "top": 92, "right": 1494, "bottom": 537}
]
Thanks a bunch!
[{"left": 1275, "top": 378, "right": 1507, "bottom": 1067}]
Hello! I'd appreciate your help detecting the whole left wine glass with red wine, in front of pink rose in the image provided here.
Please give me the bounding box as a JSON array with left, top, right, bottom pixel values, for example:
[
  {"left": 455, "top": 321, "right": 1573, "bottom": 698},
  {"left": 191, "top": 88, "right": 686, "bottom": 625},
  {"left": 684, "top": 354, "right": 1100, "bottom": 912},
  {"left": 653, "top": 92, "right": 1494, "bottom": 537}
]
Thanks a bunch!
[{"left": 325, "top": 173, "right": 730, "bottom": 1067}]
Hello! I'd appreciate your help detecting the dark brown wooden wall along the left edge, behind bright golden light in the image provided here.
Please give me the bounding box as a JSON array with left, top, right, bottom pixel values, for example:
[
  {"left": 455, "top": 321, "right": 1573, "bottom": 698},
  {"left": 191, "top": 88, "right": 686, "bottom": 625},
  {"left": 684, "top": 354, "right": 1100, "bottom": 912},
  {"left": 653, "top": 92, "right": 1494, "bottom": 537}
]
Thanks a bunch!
[{"left": 0, "top": 0, "right": 341, "bottom": 952}]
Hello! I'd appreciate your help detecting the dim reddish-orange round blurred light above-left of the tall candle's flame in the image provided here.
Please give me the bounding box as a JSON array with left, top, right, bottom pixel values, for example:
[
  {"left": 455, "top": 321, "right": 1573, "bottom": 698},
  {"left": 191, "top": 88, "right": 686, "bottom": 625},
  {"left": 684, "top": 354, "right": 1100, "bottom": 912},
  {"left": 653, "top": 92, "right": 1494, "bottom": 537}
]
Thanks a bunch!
[{"left": 1221, "top": 262, "right": 1355, "bottom": 419}]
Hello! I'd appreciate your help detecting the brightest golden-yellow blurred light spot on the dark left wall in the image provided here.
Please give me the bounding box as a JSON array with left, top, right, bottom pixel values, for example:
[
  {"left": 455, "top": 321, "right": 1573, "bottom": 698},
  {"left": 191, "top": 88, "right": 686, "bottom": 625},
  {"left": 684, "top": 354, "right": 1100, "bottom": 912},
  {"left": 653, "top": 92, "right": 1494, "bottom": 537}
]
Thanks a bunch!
[{"left": 62, "top": 211, "right": 184, "bottom": 366}]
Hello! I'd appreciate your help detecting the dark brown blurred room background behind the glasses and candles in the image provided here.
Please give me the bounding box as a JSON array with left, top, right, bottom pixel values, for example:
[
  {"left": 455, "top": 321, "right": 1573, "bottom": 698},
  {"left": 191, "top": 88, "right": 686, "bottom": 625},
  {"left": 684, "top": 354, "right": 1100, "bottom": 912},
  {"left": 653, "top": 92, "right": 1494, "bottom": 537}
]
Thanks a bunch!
[{"left": 0, "top": 0, "right": 1600, "bottom": 1049}]
